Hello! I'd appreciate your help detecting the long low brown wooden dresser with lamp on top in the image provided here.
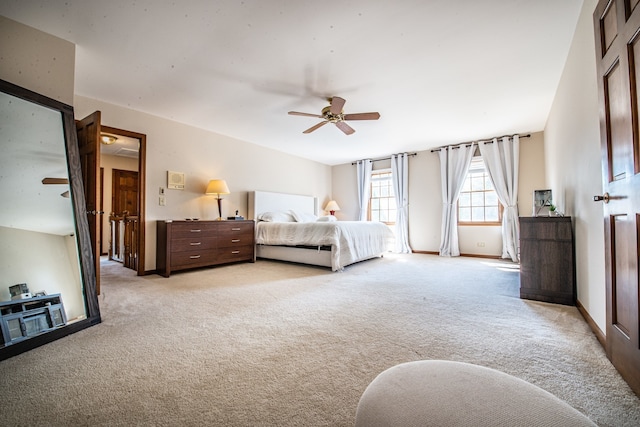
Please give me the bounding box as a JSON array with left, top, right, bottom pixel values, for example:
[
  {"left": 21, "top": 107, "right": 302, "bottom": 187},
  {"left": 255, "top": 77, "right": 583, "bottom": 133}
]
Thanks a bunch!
[{"left": 156, "top": 220, "right": 256, "bottom": 277}]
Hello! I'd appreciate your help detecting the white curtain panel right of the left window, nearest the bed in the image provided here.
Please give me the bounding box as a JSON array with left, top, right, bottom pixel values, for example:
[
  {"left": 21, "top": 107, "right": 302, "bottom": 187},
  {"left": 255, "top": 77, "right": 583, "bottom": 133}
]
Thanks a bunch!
[{"left": 391, "top": 153, "right": 411, "bottom": 254}]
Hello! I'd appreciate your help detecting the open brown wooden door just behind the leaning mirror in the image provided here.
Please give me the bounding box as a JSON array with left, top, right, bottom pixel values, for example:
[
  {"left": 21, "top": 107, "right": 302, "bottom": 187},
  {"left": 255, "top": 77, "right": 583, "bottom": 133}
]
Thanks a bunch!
[{"left": 76, "top": 111, "right": 102, "bottom": 294}]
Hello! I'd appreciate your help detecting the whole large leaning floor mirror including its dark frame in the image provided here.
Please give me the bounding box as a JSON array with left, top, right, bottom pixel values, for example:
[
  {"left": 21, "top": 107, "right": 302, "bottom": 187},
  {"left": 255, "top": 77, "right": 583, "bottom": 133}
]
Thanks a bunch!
[{"left": 0, "top": 80, "right": 100, "bottom": 360}]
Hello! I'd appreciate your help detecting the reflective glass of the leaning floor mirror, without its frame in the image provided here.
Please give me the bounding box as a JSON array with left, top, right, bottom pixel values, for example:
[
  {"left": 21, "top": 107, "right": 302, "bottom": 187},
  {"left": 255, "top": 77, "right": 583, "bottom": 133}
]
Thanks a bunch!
[{"left": 0, "top": 89, "right": 87, "bottom": 348}]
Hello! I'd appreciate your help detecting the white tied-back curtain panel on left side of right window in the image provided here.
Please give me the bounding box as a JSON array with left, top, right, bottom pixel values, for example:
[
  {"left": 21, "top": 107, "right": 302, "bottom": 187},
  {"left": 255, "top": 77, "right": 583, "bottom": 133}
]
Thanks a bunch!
[{"left": 438, "top": 143, "right": 475, "bottom": 256}]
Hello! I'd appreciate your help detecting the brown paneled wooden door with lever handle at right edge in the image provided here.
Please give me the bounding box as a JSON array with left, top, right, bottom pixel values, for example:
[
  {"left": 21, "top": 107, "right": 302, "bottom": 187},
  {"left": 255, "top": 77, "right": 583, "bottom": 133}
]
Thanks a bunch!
[{"left": 594, "top": 0, "right": 640, "bottom": 394}]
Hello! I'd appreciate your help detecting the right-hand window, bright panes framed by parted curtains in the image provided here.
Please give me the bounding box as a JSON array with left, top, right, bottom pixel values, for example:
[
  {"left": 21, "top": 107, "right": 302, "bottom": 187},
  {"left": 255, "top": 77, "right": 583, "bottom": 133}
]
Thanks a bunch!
[{"left": 458, "top": 157, "right": 502, "bottom": 225}]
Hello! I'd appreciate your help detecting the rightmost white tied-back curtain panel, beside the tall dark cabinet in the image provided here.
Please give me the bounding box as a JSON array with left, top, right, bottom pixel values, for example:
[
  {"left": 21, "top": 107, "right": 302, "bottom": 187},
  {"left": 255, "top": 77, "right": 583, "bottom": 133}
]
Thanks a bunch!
[{"left": 478, "top": 135, "right": 520, "bottom": 262}]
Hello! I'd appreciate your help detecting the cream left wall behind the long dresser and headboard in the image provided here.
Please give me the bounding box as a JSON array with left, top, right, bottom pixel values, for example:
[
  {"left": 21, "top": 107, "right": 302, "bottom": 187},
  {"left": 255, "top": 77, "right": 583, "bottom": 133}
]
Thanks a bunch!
[{"left": 74, "top": 96, "right": 331, "bottom": 270}]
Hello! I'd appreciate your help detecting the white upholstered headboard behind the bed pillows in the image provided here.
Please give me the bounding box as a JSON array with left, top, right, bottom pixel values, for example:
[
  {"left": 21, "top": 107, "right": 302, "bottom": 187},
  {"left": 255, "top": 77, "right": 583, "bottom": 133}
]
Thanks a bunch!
[{"left": 247, "top": 191, "right": 318, "bottom": 221}]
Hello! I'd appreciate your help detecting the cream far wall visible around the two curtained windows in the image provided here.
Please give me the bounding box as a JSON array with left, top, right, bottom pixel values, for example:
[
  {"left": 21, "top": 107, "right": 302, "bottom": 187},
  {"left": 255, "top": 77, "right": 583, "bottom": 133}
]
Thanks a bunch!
[{"left": 330, "top": 132, "right": 545, "bottom": 256}]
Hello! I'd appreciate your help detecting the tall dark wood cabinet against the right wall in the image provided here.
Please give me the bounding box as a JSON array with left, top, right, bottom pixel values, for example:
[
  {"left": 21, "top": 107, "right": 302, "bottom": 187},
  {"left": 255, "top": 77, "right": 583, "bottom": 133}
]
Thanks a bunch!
[{"left": 520, "top": 217, "right": 576, "bottom": 305}]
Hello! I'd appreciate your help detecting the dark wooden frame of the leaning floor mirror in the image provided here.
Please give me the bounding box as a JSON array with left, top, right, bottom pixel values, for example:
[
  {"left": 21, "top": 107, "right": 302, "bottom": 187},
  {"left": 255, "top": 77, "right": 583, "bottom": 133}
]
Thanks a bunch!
[{"left": 0, "top": 79, "right": 101, "bottom": 360}]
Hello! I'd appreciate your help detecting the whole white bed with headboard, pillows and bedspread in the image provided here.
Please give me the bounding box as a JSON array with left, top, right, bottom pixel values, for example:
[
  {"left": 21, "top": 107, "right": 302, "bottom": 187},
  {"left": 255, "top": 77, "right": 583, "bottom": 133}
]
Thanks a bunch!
[{"left": 248, "top": 191, "right": 395, "bottom": 271}]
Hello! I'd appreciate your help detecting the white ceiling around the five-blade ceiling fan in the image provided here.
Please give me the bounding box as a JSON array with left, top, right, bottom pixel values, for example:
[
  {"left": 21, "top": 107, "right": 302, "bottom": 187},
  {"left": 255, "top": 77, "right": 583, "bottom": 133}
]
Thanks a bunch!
[{"left": 0, "top": 0, "right": 583, "bottom": 165}]
